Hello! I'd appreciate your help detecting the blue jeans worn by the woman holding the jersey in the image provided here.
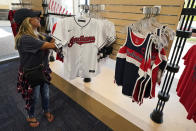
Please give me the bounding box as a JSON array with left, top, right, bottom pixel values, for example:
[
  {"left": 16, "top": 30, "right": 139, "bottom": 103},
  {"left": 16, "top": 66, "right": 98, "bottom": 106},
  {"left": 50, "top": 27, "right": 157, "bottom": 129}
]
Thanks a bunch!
[{"left": 28, "top": 83, "right": 49, "bottom": 118}]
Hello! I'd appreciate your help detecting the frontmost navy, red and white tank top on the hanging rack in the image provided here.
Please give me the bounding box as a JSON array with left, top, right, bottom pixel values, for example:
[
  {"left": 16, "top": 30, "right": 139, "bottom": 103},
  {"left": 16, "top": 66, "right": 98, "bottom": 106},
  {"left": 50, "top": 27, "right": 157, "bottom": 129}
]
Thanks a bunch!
[{"left": 115, "top": 28, "right": 151, "bottom": 96}]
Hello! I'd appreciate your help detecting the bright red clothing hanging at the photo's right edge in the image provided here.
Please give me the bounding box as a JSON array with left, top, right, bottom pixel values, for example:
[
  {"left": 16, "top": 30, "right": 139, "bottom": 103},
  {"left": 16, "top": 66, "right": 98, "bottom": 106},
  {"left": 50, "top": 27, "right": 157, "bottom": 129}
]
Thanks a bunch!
[{"left": 176, "top": 45, "right": 196, "bottom": 122}]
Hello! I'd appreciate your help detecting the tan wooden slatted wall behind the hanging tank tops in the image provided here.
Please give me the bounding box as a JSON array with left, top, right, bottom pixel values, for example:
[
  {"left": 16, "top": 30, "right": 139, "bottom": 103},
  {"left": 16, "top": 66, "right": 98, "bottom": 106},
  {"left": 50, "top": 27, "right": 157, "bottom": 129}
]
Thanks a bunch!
[{"left": 90, "top": 0, "right": 184, "bottom": 59}]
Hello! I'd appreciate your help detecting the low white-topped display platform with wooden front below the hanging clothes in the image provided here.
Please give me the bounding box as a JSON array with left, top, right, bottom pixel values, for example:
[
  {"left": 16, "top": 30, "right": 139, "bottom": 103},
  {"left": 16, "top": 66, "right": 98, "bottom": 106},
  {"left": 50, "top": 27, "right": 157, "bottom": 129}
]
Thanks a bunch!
[{"left": 50, "top": 59, "right": 196, "bottom": 131}]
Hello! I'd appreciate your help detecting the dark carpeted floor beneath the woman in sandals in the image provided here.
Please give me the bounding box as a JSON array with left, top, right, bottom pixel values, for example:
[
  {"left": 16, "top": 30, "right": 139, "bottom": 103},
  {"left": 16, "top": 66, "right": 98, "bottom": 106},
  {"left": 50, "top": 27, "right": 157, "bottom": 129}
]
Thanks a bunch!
[{"left": 0, "top": 60, "right": 111, "bottom": 131}]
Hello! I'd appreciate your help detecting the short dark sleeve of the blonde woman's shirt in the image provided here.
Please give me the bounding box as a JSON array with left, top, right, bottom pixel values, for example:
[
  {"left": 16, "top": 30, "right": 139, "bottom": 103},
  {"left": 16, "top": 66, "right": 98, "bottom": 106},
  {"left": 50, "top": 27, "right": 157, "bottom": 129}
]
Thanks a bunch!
[{"left": 21, "top": 35, "right": 44, "bottom": 54}]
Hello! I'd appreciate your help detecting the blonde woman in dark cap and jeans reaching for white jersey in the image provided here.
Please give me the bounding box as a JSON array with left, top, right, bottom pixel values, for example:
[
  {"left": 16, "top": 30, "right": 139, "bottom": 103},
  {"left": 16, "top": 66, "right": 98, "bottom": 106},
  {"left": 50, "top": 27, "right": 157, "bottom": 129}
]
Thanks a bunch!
[{"left": 14, "top": 9, "right": 56, "bottom": 127}]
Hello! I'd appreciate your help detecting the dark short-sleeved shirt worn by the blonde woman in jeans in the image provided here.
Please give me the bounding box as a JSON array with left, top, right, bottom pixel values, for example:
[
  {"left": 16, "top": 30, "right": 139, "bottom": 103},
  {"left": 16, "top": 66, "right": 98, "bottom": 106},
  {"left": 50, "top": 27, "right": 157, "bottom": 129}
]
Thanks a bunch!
[{"left": 17, "top": 35, "right": 52, "bottom": 68}]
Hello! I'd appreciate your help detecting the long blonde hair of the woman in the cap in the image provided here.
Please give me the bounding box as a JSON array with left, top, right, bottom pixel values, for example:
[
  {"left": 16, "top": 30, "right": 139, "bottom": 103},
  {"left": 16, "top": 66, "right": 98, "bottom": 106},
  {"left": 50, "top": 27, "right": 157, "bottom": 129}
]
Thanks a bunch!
[{"left": 15, "top": 17, "right": 45, "bottom": 50}]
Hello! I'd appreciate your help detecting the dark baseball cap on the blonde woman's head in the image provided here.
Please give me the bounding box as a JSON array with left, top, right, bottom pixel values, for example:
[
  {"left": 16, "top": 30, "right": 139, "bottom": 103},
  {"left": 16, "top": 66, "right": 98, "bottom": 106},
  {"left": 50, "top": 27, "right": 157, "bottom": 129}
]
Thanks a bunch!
[{"left": 14, "top": 8, "right": 41, "bottom": 25}]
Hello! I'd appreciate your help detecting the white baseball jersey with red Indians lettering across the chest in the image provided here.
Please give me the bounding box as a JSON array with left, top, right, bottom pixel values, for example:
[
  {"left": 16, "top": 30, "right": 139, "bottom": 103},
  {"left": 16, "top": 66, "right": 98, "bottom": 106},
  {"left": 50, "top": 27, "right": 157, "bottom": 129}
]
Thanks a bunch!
[{"left": 53, "top": 17, "right": 116, "bottom": 79}]
